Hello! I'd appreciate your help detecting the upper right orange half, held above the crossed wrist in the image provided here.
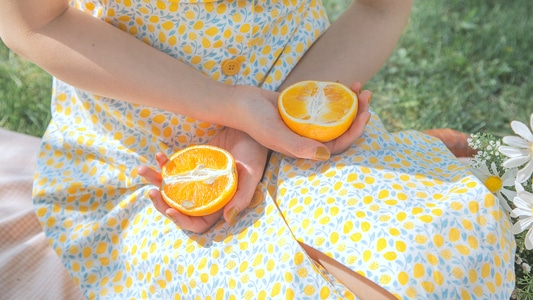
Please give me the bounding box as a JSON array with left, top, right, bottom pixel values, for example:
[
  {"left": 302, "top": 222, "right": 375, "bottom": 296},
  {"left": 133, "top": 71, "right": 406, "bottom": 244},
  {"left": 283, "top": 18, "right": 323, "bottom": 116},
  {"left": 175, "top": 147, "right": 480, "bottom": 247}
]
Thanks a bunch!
[{"left": 278, "top": 80, "right": 358, "bottom": 142}]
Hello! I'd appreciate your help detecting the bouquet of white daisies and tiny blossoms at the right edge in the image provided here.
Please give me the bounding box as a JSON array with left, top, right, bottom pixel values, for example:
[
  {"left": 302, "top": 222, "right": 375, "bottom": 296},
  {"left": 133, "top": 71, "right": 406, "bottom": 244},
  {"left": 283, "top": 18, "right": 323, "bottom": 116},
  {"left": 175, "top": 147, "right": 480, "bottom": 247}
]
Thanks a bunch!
[{"left": 468, "top": 114, "right": 533, "bottom": 299}]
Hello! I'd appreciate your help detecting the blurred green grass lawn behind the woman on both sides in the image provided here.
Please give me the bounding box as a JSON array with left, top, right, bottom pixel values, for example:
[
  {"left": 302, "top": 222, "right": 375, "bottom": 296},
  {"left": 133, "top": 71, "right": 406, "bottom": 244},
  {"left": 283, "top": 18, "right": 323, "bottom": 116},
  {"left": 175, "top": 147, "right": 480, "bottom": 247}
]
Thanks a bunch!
[{"left": 0, "top": 0, "right": 533, "bottom": 136}]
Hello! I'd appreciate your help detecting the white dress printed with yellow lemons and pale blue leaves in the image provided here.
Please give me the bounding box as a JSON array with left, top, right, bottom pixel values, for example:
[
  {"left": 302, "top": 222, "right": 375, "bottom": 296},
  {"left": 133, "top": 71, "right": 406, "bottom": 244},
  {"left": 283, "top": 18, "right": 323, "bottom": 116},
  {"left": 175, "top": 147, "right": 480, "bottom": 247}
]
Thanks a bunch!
[{"left": 34, "top": 0, "right": 515, "bottom": 299}]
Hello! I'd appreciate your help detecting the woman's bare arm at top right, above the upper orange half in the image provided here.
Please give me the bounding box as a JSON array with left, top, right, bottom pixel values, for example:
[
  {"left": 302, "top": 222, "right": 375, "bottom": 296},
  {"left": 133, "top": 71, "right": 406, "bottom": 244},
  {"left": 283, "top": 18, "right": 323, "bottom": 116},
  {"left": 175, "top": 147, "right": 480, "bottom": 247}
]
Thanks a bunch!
[{"left": 281, "top": 0, "right": 413, "bottom": 88}]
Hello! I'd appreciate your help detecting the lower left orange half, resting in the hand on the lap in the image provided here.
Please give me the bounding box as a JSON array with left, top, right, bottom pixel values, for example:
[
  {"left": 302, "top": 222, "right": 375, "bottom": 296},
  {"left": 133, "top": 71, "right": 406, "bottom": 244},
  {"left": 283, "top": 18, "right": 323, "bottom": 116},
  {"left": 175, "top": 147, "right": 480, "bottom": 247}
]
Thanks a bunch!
[{"left": 161, "top": 145, "right": 237, "bottom": 216}]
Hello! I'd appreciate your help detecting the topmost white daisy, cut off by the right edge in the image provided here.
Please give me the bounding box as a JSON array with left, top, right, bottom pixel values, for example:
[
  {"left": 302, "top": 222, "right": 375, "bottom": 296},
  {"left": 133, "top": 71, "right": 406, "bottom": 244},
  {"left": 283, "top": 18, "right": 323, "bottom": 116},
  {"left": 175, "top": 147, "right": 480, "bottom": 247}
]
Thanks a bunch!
[{"left": 499, "top": 114, "right": 533, "bottom": 183}]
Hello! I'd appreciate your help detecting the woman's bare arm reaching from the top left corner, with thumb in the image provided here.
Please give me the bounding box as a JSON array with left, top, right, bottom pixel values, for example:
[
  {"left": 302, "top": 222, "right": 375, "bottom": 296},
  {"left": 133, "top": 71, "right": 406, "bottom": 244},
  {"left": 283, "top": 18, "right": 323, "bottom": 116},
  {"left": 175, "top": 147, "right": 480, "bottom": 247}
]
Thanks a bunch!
[{"left": 0, "top": 0, "right": 332, "bottom": 158}]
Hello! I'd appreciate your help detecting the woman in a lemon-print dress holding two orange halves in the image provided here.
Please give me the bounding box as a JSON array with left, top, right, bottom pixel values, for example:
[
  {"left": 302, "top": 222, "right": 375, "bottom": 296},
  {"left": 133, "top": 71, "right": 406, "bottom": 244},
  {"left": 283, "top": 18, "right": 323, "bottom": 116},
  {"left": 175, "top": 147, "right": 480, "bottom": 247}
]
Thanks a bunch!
[{"left": 0, "top": 0, "right": 514, "bottom": 299}]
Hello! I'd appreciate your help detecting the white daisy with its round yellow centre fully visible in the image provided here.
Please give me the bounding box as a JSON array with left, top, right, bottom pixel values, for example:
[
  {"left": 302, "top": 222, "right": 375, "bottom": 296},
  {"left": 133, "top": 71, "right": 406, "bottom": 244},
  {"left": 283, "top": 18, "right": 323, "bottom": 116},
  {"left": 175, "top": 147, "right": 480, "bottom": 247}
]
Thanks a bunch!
[{"left": 472, "top": 162, "right": 518, "bottom": 212}]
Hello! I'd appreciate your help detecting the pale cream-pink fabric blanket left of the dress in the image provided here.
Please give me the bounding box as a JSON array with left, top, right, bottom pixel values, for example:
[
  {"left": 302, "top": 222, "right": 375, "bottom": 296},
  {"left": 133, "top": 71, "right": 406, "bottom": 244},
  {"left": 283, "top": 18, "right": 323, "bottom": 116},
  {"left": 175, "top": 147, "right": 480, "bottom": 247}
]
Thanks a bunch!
[{"left": 0, "top": 128, "right": 84, "bottom": 299}]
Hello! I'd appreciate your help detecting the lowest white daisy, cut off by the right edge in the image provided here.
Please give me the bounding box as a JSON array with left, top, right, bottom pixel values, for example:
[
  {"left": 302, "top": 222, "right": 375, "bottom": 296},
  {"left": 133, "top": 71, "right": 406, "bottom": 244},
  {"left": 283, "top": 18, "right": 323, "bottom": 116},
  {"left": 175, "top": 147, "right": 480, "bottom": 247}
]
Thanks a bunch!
[{"left": 511, "top": 190, "right": 533, "bottom": 250}]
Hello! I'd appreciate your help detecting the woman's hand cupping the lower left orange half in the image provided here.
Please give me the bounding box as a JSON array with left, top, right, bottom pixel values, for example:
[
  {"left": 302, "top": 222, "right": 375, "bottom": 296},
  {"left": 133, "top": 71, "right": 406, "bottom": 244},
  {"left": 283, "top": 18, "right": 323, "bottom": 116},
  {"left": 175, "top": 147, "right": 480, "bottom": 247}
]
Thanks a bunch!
[{"left": 139, "top": 128, "right": 268, "bottom": 233}]
